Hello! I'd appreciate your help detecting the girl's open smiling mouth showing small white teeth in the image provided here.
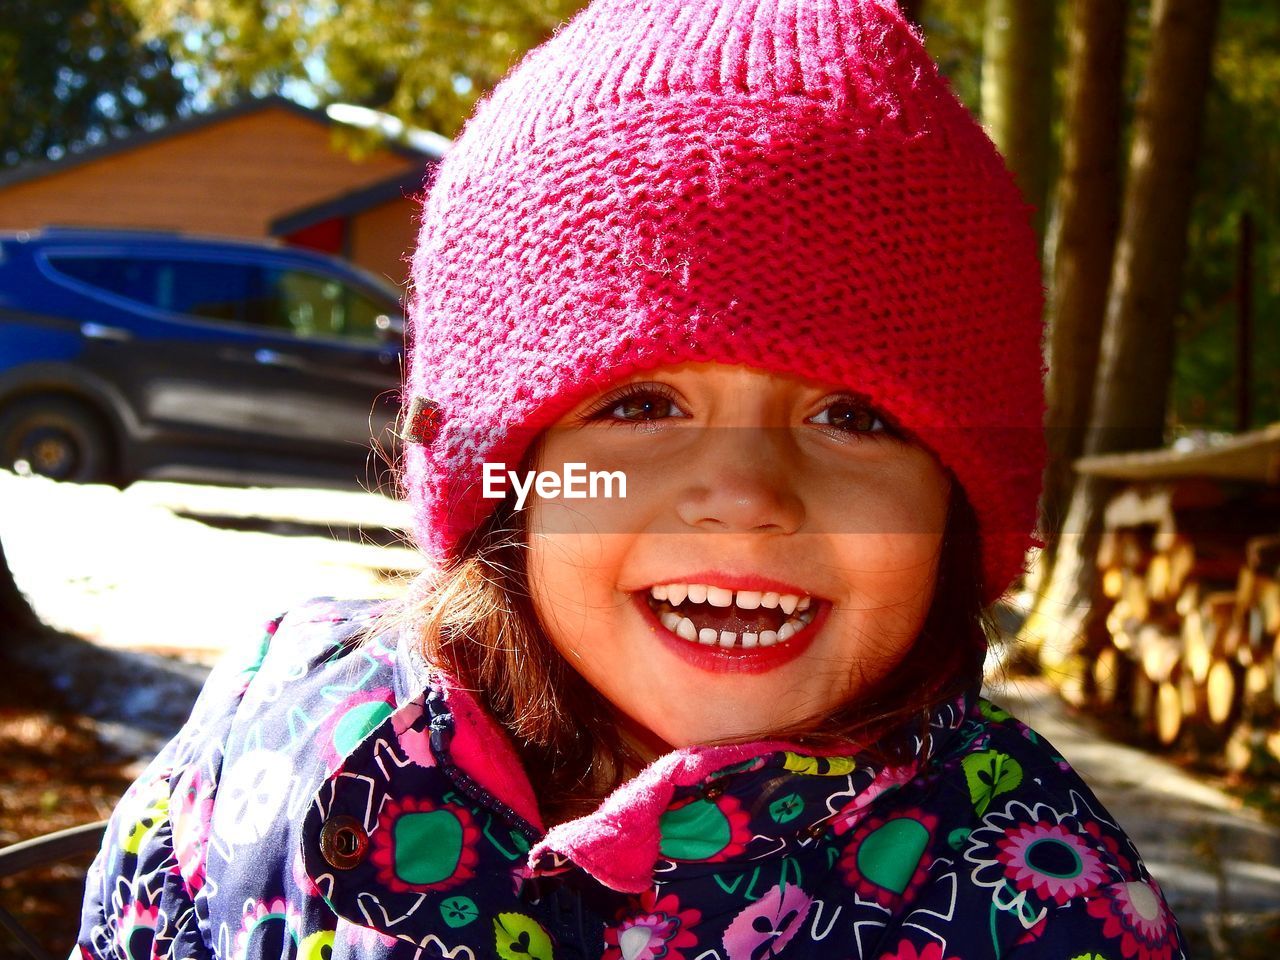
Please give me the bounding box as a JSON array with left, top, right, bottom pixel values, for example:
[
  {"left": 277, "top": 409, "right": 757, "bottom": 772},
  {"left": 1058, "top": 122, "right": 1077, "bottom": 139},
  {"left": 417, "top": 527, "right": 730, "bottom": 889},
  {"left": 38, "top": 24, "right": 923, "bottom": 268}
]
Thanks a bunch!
[{"left": 645, "top": 584, "right": 823, "bottom": 650}]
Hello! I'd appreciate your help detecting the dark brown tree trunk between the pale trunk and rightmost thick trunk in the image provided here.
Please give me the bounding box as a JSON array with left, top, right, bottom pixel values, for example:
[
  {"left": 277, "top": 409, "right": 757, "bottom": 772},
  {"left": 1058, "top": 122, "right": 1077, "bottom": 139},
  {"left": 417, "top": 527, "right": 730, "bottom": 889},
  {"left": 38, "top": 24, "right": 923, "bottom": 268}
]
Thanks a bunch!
[{"left": 1041, "top": 0, "right": 1129, "bottom": 557}]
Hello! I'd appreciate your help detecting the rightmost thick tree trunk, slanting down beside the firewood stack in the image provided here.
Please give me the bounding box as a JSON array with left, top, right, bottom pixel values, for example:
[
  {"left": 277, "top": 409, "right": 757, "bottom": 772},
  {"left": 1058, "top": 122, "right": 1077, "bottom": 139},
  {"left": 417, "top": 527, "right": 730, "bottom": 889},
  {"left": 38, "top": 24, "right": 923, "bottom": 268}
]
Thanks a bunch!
[{"left": 1028, "top": 0, "right": 1220, "bottom": 669}]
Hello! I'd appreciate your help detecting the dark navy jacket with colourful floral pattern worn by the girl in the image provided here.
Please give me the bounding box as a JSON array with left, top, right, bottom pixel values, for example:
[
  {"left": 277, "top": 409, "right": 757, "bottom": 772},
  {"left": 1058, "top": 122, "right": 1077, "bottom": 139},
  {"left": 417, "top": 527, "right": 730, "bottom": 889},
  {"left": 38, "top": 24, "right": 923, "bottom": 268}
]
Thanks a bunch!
[{"left": 78, "top": 602, "right": 1185, "bottom": 960}]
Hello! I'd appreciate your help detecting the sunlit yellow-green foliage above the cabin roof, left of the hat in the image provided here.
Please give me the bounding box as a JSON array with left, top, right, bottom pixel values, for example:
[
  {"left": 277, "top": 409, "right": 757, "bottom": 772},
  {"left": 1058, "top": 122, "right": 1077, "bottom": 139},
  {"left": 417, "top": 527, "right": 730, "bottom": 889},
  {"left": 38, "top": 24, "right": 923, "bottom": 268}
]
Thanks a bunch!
[{"left": 128, "top": 0, "right": 585, "bottom": 137}]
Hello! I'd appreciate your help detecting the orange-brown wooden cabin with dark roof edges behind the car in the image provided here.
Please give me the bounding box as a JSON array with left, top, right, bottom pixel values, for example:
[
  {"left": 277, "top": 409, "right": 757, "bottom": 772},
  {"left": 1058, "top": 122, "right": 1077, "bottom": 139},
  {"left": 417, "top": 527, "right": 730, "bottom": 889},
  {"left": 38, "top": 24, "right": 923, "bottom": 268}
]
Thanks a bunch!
[{"left": 0, "top": 97, "right": 440, "bottom": 295}]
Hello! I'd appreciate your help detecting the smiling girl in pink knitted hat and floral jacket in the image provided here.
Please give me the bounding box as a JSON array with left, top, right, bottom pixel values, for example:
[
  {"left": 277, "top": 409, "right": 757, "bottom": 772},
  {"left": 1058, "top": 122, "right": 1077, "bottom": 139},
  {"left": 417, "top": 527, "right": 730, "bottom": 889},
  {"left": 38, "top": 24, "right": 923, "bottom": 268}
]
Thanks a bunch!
[{"left": 79, "top": 0, "right": 1185, "bottom": 960}]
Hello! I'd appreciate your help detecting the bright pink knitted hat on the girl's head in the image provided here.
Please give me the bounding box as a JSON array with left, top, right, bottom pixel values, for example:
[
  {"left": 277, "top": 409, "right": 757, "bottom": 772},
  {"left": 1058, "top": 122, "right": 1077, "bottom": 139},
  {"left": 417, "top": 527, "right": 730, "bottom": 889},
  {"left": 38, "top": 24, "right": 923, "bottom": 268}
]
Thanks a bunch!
[{"left": 403, "top": 0, "right": 1044, "bottom": 602}]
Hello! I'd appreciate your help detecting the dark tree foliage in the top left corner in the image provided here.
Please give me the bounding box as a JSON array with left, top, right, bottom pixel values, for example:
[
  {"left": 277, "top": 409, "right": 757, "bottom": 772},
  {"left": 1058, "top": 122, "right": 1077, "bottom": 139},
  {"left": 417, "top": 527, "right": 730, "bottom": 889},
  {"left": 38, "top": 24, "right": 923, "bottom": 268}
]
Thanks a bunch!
[{"left": 0, "top": 0, "right": 187, "bottom": 166}]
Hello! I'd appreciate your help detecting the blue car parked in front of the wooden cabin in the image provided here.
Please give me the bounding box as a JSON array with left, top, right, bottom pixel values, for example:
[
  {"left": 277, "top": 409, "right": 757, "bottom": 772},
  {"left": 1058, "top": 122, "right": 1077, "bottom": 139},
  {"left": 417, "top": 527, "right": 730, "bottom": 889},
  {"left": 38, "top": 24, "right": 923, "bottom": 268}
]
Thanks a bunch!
[{"left": 0, "top": 228, "right": 404, "bottom": 486}]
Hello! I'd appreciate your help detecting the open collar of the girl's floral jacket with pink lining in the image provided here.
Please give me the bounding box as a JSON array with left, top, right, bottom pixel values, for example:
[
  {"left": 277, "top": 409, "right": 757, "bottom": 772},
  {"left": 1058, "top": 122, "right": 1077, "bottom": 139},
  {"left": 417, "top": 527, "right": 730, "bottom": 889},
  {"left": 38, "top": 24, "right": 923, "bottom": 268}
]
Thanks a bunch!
[{"left": 296, "top": 624, "right": 977, "bottom": 952}]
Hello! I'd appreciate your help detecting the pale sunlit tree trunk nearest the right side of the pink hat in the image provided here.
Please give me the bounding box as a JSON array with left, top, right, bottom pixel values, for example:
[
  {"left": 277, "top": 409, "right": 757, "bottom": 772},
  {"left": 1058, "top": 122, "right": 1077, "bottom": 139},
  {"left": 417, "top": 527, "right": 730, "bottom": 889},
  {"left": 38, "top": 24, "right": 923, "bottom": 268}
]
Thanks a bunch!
[{"left": 982, "top": 0, "right": 1057, "bottom": 244}]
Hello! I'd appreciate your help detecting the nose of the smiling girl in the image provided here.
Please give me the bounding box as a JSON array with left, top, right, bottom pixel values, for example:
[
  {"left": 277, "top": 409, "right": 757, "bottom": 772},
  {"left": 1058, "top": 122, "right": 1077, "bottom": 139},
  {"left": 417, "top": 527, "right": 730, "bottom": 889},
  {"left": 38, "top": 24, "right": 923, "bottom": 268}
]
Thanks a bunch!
[{"left": 676, "top": 428, "right": 805, "bottom": 534}]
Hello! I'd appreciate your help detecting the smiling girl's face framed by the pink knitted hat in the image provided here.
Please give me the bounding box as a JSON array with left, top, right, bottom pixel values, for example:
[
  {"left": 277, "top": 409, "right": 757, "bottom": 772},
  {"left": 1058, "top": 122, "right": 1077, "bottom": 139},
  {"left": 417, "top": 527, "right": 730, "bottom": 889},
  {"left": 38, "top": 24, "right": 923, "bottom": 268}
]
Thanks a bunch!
[{"left": 521, "top": 364, "right": 950, "bottom": 756}]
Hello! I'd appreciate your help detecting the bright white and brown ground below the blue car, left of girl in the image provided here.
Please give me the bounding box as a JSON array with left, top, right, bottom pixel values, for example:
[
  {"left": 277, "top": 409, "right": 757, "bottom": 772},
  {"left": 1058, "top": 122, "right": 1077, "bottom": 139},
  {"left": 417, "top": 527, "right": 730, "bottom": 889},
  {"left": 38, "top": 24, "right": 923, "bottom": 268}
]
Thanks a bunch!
[{"left": 0, "top": 471, "right": 421, "bottom": 960}]
